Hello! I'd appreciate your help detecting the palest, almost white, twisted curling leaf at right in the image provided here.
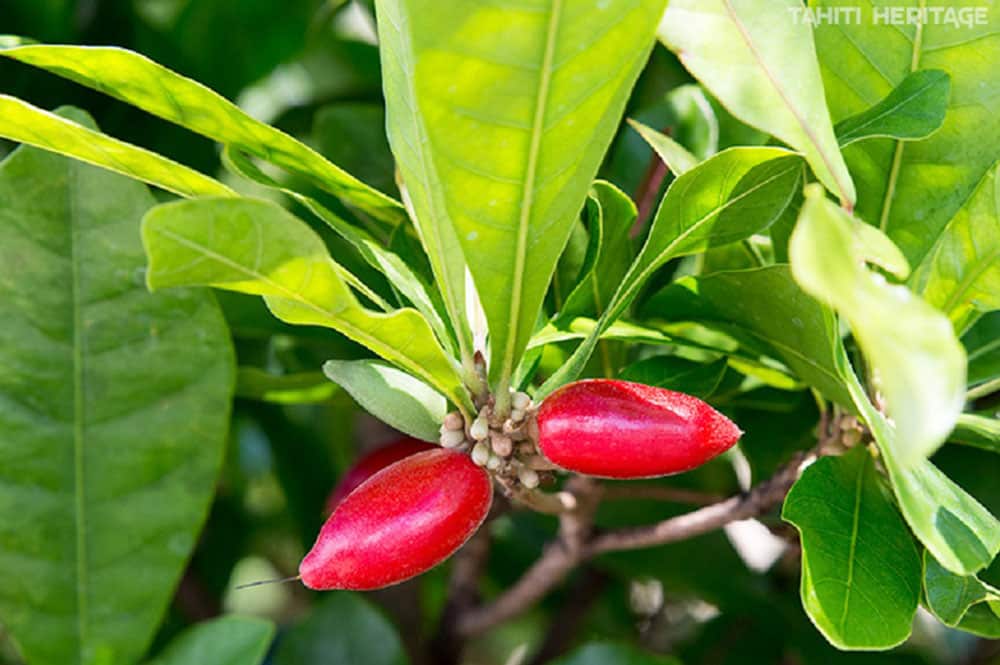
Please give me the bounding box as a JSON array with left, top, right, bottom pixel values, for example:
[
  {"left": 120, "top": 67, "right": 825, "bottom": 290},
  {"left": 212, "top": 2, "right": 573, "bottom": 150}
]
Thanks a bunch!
[{"left": 789, "top": 185, "right": 966, "bottom": 466}]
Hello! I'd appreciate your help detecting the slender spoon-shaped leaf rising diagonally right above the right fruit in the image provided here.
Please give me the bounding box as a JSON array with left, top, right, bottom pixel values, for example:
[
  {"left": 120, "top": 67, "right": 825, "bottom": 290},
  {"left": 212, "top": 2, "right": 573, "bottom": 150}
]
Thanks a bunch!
[{"left": 539, "top": 148, "right": 802, "bottom": 396}]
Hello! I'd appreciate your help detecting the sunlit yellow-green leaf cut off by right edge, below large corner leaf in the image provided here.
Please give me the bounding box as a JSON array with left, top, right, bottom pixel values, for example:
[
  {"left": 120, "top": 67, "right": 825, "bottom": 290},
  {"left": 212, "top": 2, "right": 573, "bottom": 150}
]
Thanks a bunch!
[{"left": 913, "top": 163, "right": 1000, "bottom": 331}]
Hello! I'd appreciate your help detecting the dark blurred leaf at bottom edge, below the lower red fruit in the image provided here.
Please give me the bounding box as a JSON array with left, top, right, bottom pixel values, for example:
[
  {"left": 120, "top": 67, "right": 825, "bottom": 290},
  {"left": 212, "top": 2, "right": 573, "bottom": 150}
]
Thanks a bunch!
[{"left": 274, "top": 591, "right": 409, "bottom": 665}]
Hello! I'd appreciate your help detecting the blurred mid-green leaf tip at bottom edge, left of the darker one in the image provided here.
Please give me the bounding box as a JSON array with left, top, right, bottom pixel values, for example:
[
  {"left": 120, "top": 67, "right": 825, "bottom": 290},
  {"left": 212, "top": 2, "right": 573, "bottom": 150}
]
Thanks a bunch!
[{"left": 148, "top": 616, "right": 274, "bottom": 665}]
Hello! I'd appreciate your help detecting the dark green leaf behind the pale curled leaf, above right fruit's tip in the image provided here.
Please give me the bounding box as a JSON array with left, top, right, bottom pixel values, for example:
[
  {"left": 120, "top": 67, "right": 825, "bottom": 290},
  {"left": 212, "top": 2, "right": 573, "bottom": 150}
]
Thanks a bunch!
[{"left": 642, "top": 265, "right": 851, "bottom": 406}]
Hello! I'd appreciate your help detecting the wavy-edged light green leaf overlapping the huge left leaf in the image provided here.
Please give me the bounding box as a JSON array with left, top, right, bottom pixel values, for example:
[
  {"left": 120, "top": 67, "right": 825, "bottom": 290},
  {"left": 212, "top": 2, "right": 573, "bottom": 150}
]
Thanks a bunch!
[{"left": 142, "top": 199, "right": 469, "bottom": 408}]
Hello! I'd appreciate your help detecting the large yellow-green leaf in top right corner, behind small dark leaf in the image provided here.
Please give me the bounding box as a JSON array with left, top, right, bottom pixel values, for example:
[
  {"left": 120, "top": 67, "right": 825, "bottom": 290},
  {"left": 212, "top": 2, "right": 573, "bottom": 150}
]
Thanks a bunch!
[{"left": 810, "top": 0, "right": 1000, "bottom": 266}]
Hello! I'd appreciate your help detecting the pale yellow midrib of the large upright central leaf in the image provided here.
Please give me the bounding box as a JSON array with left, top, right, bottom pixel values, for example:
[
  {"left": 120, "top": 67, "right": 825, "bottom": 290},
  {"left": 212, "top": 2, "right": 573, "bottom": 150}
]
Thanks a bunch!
[{"left": 499, "top": 0, "right": 563, "bottom": 394}]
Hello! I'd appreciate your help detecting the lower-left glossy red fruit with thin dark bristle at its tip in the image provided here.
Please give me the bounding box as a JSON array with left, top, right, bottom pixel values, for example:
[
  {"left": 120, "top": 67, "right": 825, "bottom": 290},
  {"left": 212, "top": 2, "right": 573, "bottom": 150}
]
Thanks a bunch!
[{"left": 299, "top": 448, "right": 493, "bottom": 591}]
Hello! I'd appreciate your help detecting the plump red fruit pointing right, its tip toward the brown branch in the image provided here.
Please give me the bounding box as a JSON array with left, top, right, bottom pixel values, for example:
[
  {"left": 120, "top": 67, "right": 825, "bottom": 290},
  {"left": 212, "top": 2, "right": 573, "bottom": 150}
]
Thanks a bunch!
[{"left": 538, "top": 379, "right": 743, "bottom": 478}]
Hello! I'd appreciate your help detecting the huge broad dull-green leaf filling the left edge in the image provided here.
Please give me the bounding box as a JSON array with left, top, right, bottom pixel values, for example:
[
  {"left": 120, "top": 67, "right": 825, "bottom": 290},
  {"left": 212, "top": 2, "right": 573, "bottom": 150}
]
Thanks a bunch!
[{"left": 0, "top": 112, "right": 234, "bottom": 665}]
